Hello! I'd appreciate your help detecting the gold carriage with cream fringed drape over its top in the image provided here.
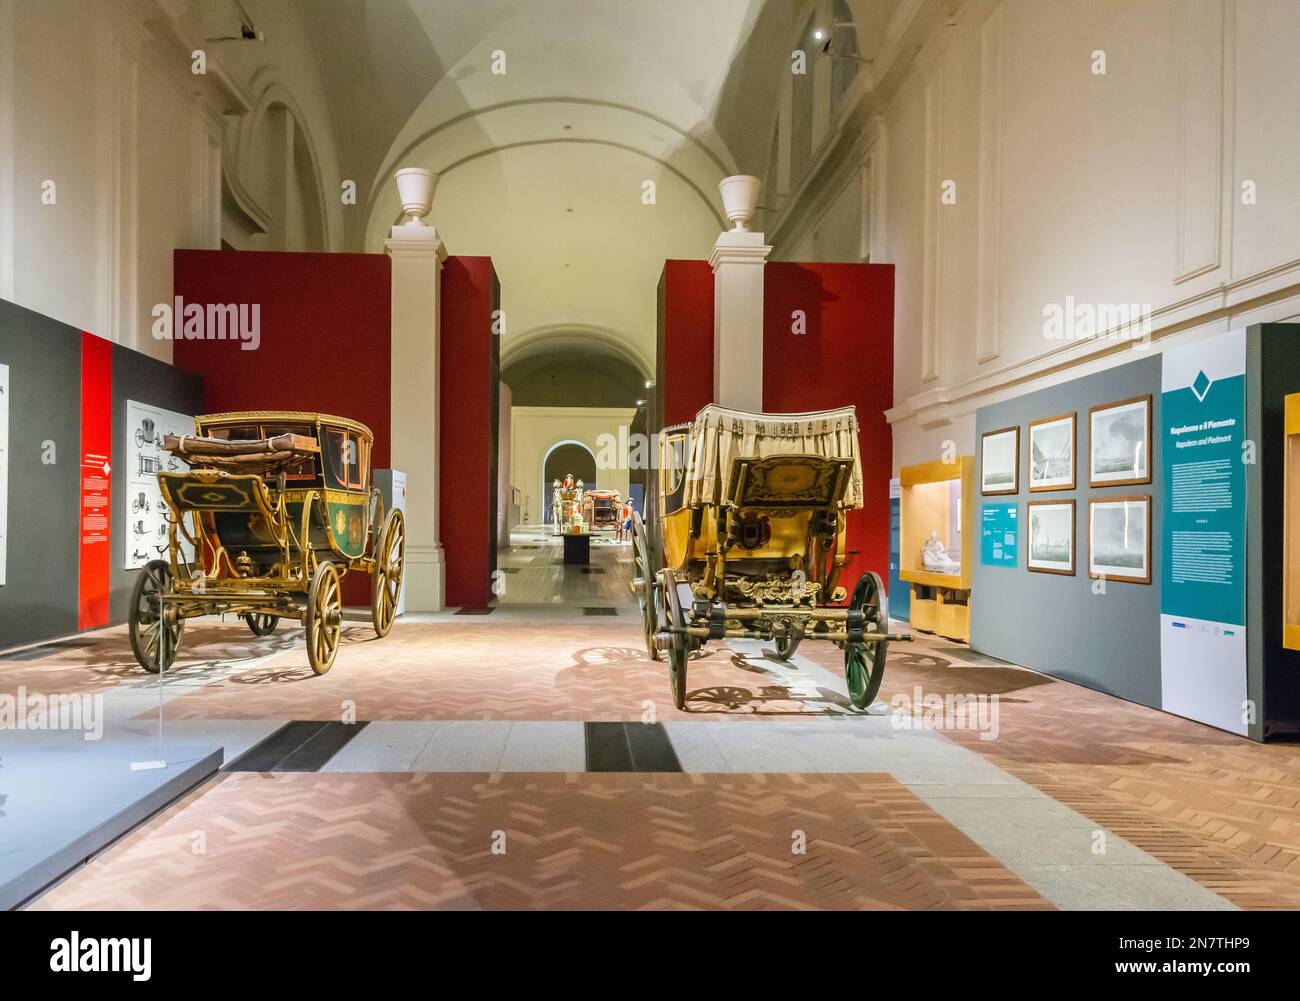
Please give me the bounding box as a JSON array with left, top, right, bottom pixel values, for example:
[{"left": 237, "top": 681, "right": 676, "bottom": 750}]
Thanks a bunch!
[{"left": 632, "top": 407, "right": 911, "bottom": 709}]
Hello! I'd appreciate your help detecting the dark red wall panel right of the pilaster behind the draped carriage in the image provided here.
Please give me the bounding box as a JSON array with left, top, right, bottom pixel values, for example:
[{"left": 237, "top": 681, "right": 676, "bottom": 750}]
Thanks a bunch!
[{"left": 763, "top": 261, "right": 894, "bottom": 592}]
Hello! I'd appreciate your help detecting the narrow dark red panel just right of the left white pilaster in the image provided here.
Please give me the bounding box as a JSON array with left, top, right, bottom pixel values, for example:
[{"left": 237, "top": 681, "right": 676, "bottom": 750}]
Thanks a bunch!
[{"left": 438, "top": 257, "right": 501, "bottom": 608}]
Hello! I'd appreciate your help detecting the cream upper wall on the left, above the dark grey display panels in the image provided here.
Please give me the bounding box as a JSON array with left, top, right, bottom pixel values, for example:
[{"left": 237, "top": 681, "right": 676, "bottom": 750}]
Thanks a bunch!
[{"left": 0, "top": 0, "right": 342, "bottom": 360}]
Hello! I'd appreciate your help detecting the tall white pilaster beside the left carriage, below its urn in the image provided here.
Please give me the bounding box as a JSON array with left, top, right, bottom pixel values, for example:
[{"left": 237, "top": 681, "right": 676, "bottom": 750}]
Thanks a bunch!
[{"left": 384, "top": 224, "right": 447, "bottom": 612}]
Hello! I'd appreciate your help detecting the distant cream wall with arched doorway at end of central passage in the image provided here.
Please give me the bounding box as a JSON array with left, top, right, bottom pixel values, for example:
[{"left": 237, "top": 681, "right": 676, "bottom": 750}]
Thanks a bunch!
[{"left": 510, "top": 407, "right": 636, "bottom": 525}]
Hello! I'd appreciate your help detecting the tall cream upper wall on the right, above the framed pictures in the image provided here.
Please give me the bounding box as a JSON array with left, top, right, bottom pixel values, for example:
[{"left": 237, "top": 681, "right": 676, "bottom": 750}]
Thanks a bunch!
[{"left": 768, "top": 0, "right": 1300, "bottom": 467}]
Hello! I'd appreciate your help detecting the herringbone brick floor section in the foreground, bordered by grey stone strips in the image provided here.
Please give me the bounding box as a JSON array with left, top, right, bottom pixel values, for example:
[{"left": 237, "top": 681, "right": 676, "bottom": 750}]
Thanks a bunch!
[{"left": 27, "top": 772, "right": 1050, "bottom": 910}]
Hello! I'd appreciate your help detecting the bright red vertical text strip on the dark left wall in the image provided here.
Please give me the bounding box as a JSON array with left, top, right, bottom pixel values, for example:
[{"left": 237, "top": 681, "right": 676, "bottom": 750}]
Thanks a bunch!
[{"left": 77, "top": 332, "right": 113, "bottom": 629}]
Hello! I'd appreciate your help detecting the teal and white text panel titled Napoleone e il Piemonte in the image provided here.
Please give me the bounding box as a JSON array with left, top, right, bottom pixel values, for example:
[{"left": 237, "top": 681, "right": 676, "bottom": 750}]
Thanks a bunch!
[{"left": 1160, "top": 330, "right": 1247, "bottom": 733}]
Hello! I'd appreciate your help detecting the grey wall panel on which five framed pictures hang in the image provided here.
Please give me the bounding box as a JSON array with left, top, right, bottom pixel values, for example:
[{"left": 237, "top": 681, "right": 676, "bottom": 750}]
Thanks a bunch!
[{"left": 971, "top": 352, "right": 1164, "bottom": 709}]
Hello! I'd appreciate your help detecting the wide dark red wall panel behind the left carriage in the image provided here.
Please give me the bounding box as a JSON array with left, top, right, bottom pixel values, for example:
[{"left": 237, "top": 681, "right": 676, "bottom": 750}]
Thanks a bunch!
[{"left": 172, "top": 251, "right": 391, "bottom": 605}]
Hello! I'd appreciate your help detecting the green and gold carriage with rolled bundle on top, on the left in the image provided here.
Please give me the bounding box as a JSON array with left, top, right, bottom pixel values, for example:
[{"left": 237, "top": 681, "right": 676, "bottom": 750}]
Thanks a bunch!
[{"left": 127, "top": 411, "right": 406, "bottom": 675}]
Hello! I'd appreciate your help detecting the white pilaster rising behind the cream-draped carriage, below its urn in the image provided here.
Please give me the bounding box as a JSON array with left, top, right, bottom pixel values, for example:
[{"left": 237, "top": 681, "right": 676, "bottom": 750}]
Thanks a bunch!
[{"left": 709, "top": 229, "right": 772, "bottom": 411}]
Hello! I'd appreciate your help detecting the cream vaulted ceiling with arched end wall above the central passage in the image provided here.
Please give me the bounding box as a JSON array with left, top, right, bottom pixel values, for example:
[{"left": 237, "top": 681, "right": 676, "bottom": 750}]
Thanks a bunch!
[{"left": 298, "top": 0, "right": 798, "bottom": 372}]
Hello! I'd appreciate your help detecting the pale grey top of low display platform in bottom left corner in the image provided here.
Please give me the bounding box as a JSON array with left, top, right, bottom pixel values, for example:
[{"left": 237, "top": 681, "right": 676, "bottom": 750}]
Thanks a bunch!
[{"left": 0, "top": 731, "right": 224, "bottom": 910}]
